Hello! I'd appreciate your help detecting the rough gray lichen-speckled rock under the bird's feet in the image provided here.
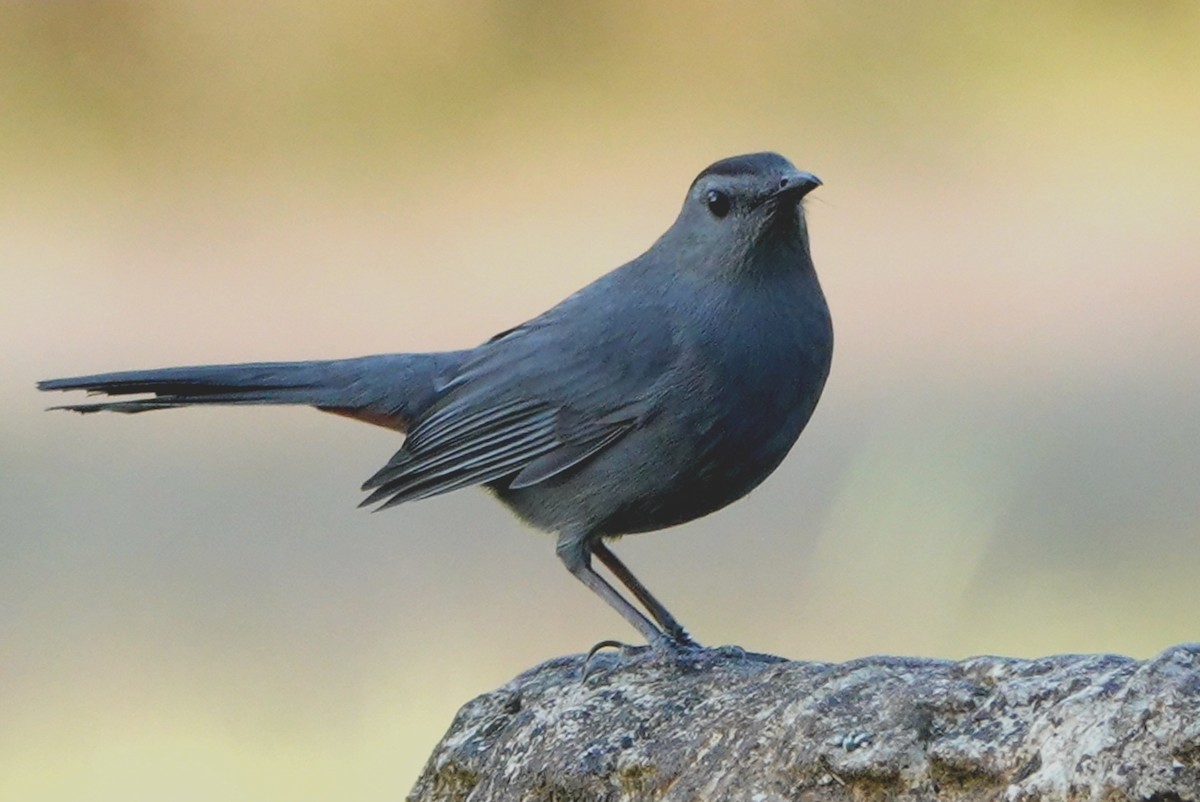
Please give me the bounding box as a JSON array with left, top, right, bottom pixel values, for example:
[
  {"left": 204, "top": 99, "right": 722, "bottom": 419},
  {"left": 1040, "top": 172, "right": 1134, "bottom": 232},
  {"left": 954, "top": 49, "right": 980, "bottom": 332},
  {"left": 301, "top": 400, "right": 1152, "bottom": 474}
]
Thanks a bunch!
[{"left": 409, "top": 644, "right": 1200, "bottom": 802}]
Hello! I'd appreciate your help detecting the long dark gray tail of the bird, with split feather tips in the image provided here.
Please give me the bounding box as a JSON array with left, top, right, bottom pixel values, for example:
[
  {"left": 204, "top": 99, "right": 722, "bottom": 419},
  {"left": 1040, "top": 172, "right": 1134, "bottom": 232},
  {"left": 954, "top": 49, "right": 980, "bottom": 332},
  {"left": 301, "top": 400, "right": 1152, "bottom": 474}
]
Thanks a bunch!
[{"left": 37, "top": 351, "right": 469, "bottom": 431}]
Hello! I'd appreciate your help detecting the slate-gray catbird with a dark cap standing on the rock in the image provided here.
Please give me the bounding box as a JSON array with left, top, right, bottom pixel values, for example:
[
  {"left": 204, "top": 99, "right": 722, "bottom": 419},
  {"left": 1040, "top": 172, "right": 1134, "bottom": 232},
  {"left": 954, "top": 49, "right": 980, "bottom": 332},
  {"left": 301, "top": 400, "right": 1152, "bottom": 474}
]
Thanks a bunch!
[{"left": 38, "top": 152, "right": 833, "bottom": 646}]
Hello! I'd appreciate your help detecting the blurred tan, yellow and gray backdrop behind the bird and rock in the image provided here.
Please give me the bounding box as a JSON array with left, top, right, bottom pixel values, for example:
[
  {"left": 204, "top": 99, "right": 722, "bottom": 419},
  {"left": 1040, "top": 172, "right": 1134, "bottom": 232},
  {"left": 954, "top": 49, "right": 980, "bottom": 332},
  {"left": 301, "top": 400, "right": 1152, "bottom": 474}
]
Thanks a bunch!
[{"left": 0, "top": 0, "right": 1200, "bottom": 801}]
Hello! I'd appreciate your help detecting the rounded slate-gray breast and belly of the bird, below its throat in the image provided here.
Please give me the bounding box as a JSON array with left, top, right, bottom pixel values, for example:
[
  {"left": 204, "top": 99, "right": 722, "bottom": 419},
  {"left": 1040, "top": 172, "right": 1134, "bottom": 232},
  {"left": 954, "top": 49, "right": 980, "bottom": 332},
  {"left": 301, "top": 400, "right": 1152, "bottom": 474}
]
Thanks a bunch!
[{"left": 492, "top": 268, "right": 833, "bottom": 535}]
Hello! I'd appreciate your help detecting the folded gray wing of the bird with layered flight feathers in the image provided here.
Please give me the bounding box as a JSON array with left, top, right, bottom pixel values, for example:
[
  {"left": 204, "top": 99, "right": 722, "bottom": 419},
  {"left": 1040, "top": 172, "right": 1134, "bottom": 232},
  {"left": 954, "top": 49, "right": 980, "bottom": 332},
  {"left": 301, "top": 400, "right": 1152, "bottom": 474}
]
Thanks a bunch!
[{"left": 362, "top": 280, "right": 677, "bottom": 509}]
